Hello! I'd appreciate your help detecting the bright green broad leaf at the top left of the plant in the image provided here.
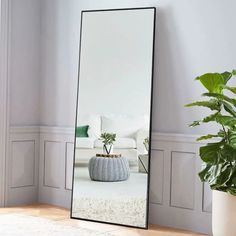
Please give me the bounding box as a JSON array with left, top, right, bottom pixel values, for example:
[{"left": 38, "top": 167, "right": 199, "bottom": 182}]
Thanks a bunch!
[{"left": 196, "top": 73, "right": 226, "bottom": 93}]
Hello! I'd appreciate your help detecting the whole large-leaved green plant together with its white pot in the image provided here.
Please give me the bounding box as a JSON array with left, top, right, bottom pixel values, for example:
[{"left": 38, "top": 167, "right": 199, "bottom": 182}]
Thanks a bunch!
[{"left": 186, "top": 70, "right": 236, "bottom": 236}]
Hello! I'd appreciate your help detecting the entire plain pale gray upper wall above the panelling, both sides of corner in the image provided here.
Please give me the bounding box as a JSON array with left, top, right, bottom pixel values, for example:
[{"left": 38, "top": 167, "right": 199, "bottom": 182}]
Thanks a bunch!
[{"left": 9, "top": 0, "right": 236, "bottom": 134}]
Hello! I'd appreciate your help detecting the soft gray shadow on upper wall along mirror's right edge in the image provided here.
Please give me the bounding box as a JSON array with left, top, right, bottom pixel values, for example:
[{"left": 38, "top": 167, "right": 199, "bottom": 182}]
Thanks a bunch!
[{"left": 153, "top": 7, "right": 187, "bottom": 133}]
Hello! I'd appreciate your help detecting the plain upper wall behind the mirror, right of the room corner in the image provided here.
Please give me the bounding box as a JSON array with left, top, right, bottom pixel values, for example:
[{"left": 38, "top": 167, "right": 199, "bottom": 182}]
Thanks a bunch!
[{"left": 40, "top": 0, "right": 236, "bottom": 134}]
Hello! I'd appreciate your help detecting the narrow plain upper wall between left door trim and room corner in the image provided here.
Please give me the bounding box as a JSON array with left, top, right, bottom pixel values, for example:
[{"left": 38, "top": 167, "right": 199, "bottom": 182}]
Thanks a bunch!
[{"left": 8, "top": 0, "right": 40, "bottom": 125}]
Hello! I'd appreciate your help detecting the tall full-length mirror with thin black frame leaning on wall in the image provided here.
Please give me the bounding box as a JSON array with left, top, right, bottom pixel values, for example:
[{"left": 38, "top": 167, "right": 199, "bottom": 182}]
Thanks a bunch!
[{"left": 71, "top": 8, "right": 155, "bottom": 228}]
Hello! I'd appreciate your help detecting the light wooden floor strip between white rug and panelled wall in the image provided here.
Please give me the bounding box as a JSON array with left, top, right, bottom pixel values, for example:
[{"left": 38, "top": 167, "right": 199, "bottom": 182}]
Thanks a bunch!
[{"left": 0, "top": 205, "right": 206, "bottom": 236}]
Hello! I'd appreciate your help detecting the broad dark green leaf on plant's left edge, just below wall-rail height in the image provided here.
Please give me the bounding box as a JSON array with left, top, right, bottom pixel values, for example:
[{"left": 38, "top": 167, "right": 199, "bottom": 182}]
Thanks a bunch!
[{"left": 200, "top": 142, "right": 222, "bottom": 165}]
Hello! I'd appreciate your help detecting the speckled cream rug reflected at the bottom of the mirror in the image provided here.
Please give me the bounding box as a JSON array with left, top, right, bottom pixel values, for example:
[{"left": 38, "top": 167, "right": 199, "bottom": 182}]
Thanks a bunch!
[{"left": 72, "top": 197, "right": 147, "bottom": 227}]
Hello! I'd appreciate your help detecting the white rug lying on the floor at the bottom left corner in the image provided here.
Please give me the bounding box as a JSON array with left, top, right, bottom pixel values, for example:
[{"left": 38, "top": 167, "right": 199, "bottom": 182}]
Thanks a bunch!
[{"left": 0, "top": 213, "right": 112, "bottom": 236}]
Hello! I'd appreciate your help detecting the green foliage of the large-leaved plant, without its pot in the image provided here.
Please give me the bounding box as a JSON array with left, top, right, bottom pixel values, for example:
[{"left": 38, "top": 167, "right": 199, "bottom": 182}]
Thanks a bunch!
[{"left": 186, "top": 70, "right": 236, "bottom": 196}]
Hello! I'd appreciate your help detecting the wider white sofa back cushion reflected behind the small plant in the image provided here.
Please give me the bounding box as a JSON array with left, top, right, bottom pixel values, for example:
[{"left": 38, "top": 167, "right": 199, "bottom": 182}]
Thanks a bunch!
[{"left": 102, "top": 115, "right": 146, "bottom": 138}]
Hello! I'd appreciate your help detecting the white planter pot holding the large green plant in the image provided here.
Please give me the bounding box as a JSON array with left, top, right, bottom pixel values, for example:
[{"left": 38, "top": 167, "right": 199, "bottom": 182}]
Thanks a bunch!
[{"left": 212, "top": 190, "right": 236, "bottom": 236}]
